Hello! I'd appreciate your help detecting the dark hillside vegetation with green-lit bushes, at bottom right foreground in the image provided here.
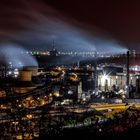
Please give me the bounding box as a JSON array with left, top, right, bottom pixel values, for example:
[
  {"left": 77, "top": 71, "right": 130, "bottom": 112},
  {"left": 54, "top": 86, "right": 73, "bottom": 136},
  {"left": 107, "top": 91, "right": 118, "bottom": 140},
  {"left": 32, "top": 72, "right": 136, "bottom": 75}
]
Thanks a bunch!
[{"left": 41, "top": 106, "right": 140, "bottom": 136}]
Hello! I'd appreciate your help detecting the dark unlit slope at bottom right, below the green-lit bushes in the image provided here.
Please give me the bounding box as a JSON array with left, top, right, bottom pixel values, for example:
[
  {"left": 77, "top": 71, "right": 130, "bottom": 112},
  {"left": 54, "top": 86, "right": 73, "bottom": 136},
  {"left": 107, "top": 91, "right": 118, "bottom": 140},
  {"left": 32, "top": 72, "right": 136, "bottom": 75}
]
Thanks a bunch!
[{"left": 33, "top": 107, "right": 140, "bottom": 140}]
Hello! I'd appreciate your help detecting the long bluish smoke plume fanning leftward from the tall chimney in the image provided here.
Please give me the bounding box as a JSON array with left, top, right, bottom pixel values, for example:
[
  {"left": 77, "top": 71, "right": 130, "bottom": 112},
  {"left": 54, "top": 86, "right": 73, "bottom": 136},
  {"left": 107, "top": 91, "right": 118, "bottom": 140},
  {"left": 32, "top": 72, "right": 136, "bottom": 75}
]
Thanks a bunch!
[{"left": 0, "top": 1, "right": 126, "bottom": 59}]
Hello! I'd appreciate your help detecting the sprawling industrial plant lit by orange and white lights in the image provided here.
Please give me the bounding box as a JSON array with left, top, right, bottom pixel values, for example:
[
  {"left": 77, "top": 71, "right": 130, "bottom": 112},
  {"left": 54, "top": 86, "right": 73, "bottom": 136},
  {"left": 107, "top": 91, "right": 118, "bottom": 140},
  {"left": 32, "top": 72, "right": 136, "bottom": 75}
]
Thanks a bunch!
[{"left": 0, "top": 47, "right": 140, "bottom": 139}]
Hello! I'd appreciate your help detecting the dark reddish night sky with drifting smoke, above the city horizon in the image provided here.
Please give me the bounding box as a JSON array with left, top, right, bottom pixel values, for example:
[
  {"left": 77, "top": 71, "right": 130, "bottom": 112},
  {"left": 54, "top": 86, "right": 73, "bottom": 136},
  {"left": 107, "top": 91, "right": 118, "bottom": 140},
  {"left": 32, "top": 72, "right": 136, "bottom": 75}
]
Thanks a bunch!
[{"left": 0, "top": 0, "right": 140, "bottom": 51}]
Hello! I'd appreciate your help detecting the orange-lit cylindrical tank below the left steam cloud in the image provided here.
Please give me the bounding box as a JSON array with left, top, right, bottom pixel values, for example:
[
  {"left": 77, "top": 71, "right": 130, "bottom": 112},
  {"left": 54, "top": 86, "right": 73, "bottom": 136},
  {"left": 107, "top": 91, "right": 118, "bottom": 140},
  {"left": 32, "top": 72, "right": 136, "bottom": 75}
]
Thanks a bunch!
[{"left": 20, "top": 70, "right": 32, "bottom": 81}]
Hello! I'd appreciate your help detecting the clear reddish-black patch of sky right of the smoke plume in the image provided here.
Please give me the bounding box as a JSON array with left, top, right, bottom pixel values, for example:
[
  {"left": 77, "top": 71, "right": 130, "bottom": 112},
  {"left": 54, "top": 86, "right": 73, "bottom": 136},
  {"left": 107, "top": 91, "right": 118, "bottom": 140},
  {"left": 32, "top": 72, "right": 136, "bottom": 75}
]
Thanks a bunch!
[{"left": 46, "top": 0, "right": 140, "bottom": 49}]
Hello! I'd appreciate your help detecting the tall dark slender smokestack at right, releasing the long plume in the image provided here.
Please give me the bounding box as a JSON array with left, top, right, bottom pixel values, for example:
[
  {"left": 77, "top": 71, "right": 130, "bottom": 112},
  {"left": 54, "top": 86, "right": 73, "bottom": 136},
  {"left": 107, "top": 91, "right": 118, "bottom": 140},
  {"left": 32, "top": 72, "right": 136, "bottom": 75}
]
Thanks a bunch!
[{"left": 126, "top": 50, "right": 130, "bottom": 98}]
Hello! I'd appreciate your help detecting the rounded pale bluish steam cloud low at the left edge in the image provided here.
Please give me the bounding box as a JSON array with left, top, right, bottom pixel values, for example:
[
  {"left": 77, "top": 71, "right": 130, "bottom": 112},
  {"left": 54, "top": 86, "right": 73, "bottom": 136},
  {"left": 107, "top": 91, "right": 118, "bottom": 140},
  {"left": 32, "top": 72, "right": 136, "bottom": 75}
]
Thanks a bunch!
[{"left": 0, "top": 44, "right": 38, "bottom": 68}]
